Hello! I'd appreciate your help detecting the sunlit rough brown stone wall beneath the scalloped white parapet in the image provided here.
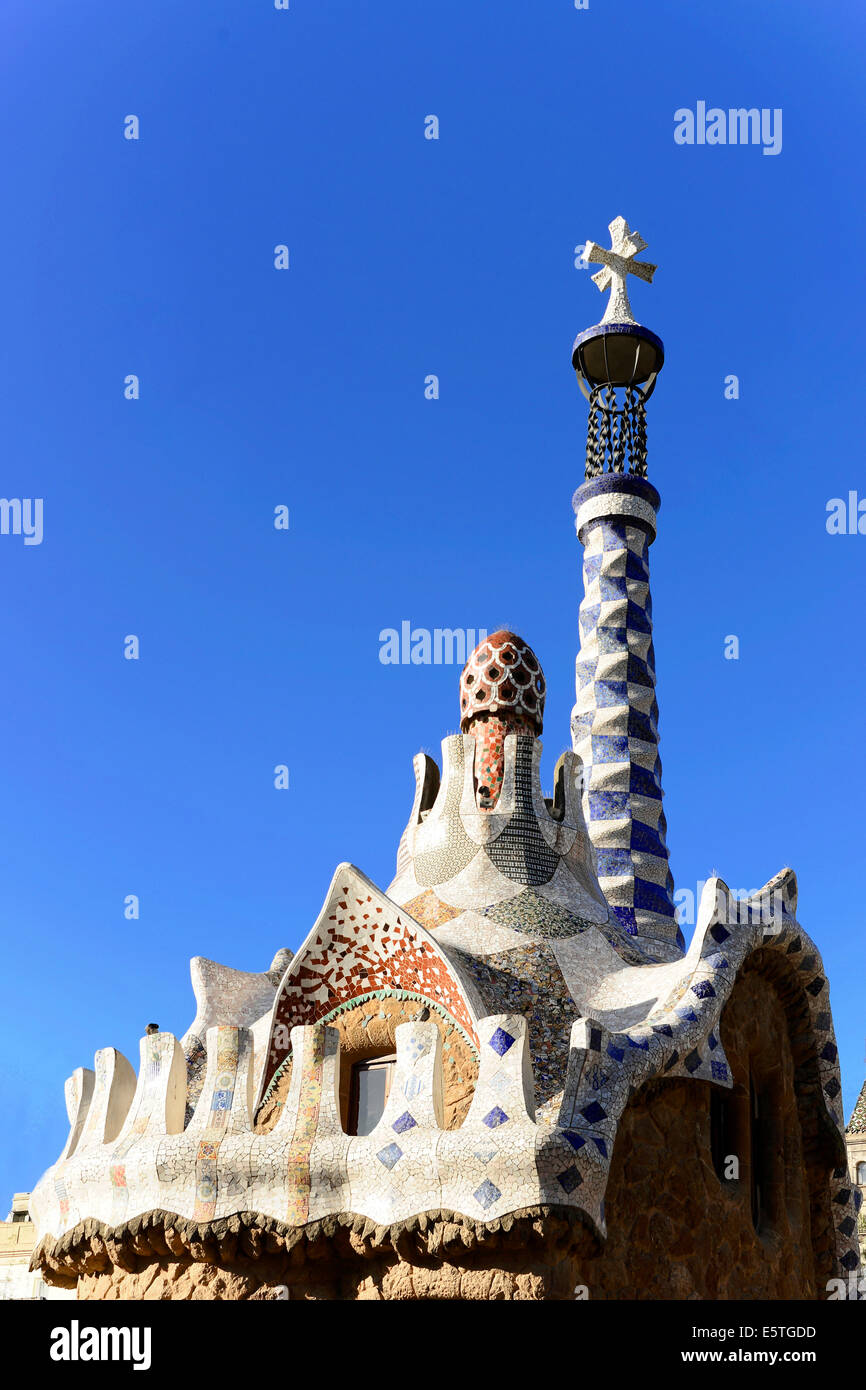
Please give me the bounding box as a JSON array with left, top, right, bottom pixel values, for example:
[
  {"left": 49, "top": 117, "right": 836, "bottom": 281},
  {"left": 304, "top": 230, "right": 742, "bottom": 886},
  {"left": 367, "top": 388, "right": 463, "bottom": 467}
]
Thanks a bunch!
[{"left": 64, "top": 1208, "right": 595, "bottom": 1300}]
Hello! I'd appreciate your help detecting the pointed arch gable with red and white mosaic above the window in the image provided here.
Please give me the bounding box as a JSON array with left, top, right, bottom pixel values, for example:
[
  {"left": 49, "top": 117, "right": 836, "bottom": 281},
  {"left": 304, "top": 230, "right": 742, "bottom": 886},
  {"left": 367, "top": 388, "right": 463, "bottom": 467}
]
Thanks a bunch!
[{"left": 263, "top": 885, "right": 478, "bottom": 1090}]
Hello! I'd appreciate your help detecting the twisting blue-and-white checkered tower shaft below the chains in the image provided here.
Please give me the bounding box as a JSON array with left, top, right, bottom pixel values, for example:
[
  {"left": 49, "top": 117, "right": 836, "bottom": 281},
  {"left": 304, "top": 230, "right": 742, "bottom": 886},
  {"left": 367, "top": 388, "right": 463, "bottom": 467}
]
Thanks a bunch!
[{"left": 571, "top": 474, "right": 685, "bottom": 960}]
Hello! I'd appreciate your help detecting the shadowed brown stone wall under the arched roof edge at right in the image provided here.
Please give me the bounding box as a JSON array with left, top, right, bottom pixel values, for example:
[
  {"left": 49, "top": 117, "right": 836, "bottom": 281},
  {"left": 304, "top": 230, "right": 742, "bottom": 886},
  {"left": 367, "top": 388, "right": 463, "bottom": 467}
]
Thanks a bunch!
[{"left": 575, "top": 951, "right": 838, "bottom": 1300}]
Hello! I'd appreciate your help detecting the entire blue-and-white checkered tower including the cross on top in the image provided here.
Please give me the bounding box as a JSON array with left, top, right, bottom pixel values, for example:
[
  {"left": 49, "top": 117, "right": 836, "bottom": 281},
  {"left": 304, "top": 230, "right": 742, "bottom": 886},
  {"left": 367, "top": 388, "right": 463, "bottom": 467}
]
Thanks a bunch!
[{"left": 571, "top": 218, "right": 684, "bottom": 960}]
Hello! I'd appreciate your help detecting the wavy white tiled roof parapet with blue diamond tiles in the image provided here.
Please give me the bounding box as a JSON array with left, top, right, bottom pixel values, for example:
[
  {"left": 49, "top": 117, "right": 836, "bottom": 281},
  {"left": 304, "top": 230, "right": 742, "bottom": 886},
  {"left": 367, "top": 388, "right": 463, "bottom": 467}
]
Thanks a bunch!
[{"left": 27, "top": 880, "right": 862, "bottom": 1270}]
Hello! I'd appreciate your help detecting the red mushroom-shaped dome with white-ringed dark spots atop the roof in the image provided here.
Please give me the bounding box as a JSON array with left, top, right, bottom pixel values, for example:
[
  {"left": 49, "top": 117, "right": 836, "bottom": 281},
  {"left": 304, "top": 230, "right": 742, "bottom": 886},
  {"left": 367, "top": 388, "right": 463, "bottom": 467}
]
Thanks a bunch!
[{"left": 460, "top": 628, "right": 548, "bottom": 734}]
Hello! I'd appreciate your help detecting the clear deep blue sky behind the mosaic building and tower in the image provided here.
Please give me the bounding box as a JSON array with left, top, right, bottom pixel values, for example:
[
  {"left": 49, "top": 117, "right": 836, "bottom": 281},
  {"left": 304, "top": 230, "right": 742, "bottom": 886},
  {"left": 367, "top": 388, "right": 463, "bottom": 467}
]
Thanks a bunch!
[{"left": 0, "top": 0, "right": 866, "bottom": 1202}]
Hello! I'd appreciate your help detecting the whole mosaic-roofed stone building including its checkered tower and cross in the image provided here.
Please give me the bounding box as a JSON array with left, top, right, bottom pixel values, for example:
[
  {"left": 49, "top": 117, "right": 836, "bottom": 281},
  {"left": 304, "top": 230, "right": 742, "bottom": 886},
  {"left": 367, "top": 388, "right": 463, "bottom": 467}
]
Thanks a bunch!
[{"left": 25, "top": 218, "right": 862, "bottom": 1300}]
